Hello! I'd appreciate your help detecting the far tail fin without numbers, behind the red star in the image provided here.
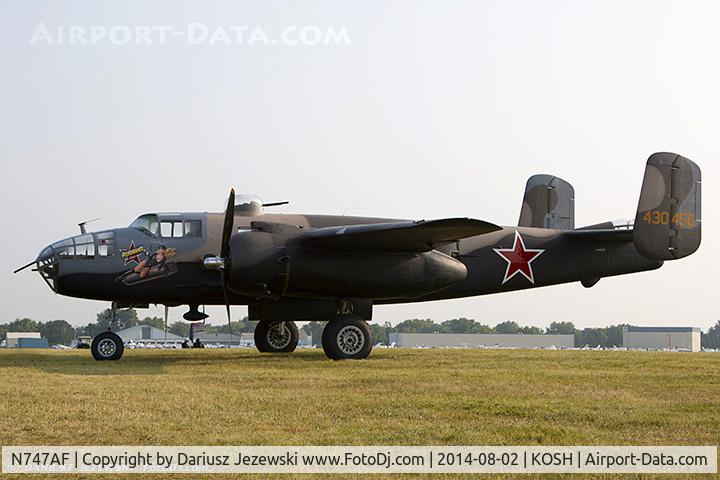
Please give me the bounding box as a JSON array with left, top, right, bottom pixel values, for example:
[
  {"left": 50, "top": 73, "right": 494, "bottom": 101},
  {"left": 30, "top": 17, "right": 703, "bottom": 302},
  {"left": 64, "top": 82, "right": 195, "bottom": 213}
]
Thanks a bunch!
[{"left": 518, "top": 175, "right": 575, "bottom": 230}]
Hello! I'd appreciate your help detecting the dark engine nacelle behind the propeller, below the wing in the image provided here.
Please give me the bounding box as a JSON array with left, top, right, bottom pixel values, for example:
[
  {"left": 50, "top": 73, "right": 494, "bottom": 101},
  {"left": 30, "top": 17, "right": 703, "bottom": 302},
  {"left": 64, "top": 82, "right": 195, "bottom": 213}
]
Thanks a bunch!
[{"left": 229, "top": 224, "right": 467, "bottom": 300}]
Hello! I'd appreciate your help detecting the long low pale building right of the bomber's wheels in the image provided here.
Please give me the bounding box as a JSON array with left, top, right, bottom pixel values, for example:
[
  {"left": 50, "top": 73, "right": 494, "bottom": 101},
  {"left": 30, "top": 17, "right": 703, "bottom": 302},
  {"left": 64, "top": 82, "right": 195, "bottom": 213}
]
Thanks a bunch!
[{"left": 389, "top": 333, "right": 575, "bottom": 348}]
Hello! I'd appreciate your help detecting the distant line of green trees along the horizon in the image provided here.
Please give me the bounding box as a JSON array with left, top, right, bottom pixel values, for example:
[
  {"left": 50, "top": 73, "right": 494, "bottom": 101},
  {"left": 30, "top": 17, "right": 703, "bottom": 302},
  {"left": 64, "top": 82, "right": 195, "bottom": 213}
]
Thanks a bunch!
[{"left": 0, "top": 309, "right": 720, "bottom": 349}]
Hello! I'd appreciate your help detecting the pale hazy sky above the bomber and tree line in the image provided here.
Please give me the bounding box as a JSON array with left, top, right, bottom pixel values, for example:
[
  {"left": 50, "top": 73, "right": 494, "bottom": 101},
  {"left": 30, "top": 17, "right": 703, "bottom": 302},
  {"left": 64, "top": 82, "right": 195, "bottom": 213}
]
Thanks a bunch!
[{"left": 0, "top": 0, "right": 720, "bottom": 328}]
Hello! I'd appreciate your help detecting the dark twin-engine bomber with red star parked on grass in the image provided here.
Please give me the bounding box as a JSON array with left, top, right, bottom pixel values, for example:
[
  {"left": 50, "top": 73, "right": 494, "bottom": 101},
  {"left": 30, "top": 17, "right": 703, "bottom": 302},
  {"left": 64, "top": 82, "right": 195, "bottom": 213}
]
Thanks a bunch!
[{"left": 16, "top": 153, "right": 700, "bottom": 360}]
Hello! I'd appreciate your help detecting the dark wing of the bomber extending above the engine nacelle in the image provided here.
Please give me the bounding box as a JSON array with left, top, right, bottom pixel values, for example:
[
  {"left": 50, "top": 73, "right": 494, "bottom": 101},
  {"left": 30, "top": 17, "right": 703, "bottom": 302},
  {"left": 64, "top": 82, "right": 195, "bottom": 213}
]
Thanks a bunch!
[{"left": 299, "top": 218, "right": 502, "bottom": 252}]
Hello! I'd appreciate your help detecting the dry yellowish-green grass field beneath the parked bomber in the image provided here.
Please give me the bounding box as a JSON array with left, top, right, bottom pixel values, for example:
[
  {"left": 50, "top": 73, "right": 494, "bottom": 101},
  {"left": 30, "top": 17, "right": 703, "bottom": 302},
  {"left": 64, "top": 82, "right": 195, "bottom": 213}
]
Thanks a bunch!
[{"left": 0, "top": 349, "right": 720, "bottom": 479}]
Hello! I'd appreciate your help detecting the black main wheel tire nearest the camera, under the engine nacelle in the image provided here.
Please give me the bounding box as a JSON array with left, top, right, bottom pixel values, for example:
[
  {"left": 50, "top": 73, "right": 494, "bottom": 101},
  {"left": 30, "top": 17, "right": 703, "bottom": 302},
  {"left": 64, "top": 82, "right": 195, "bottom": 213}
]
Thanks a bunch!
[{"left": 322, "top": 315, "right": 372, "bottom": 360}]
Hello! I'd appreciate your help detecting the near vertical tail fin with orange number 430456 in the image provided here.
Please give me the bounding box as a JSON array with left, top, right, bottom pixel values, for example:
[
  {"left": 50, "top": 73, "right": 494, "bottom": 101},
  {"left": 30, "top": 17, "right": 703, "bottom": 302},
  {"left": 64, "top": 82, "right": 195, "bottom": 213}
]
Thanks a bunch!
[{"left": 633, "top": 153, "right": 701, "bottom": 260}]
